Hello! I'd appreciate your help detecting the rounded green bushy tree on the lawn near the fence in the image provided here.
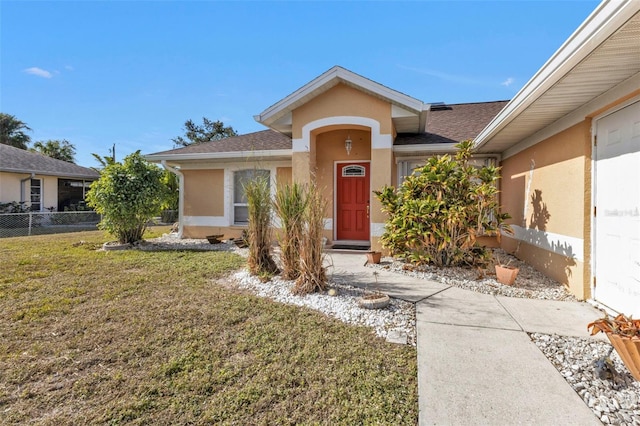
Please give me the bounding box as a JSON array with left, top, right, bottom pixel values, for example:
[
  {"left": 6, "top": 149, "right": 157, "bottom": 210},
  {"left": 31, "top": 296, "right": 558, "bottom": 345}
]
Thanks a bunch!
[{"left": 86, "top": 151, "right": 167, "bottom": 244}]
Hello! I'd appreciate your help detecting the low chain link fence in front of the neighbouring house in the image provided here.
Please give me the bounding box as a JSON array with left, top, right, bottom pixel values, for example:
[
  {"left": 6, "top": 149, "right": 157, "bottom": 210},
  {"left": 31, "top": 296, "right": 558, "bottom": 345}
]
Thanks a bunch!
[{"left": 0, "top": 211, "right": 100, "bottom": 238}]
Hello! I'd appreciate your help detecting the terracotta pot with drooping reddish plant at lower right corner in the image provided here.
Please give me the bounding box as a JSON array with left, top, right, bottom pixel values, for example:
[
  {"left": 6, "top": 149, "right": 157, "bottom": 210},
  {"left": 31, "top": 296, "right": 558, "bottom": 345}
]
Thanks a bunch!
[{"left": 587, "top": 314, "right": 640, "bottom": 381}]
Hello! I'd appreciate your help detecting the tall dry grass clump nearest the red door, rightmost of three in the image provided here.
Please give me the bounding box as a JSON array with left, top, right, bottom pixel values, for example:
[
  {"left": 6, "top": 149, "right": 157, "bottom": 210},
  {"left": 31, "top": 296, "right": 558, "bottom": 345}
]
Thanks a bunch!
[{"left": 293, "top": 182, "right": 327, "bottom": 294}]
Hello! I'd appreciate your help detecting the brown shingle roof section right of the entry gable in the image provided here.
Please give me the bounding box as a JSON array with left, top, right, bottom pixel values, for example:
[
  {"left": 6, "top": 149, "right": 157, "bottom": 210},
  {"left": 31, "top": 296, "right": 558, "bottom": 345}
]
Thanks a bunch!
[{"left": 394, "top": 101, "right": 509, "bottom": 145}]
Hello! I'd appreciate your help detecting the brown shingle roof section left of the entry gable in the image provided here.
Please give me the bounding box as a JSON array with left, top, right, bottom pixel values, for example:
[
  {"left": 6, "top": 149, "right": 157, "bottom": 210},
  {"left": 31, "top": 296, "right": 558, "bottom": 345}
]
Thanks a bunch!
[{"left": 151, "top": 129, "right": 291, "bottom": 155}]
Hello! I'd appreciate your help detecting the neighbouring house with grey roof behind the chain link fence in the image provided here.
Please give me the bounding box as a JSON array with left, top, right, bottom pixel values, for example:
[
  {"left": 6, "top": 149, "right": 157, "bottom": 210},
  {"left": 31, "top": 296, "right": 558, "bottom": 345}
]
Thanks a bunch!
[{"left": 0, "top": 144, "right": 100, "bottom": 211}]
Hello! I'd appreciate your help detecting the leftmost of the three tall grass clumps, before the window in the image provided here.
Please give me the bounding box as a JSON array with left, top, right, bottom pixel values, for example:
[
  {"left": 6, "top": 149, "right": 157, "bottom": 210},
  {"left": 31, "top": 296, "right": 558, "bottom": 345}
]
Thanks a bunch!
[{"left": 243, "top": 174, "right": 278, "bottom": 280}]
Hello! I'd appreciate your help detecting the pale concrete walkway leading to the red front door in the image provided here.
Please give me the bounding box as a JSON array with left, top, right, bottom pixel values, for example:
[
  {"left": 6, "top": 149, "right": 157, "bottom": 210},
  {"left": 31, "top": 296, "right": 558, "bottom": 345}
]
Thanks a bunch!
[{"left": 328, "top": 252, "right": 602, "bottom": 425}]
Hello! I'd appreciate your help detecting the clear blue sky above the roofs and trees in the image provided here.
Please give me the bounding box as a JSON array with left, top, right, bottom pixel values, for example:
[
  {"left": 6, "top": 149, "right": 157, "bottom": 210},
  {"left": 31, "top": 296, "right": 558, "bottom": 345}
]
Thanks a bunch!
[{"left": 0, "top": 0, "right": 598, "bottom": 166}]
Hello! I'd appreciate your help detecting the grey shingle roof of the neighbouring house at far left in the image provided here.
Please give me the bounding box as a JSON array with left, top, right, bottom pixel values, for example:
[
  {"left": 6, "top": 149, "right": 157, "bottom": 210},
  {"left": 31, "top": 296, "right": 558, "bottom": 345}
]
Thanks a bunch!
[{"left": 0, "top": 144, "right": 100, "bottom": 179}]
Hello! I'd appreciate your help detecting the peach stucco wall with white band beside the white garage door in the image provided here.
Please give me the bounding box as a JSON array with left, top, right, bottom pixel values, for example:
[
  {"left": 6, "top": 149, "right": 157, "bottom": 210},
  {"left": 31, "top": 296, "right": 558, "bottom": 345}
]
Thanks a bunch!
[{"left": 501, "top": 119, "right": 591, "bottom": 299}]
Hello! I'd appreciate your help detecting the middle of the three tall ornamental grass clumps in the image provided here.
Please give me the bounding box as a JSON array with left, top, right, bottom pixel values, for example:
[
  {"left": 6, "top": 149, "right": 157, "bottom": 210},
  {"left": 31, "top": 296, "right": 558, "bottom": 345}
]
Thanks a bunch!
[{"left": 273, "top": 183, "right": 307, "bottom": 280}]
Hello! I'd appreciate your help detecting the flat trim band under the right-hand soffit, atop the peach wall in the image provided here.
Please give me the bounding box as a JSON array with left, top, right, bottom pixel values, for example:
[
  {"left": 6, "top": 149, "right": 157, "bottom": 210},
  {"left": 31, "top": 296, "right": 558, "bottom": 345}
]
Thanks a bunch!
[{"left": 502, "top": 73, "right": 640, "bottom": 158}]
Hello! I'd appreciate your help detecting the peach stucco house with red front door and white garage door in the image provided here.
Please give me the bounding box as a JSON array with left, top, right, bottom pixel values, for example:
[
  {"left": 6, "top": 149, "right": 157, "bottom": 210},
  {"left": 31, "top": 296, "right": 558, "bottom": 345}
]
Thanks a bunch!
[{"left": 146, "top": 0, "right": 640, "bottom": 316}]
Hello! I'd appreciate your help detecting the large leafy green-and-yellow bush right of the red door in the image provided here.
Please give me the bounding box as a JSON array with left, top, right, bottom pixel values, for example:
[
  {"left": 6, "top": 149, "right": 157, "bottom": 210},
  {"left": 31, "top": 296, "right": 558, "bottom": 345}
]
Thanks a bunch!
[{"left": 375, "top": 141, "right": 511, "bottom": 266}]
